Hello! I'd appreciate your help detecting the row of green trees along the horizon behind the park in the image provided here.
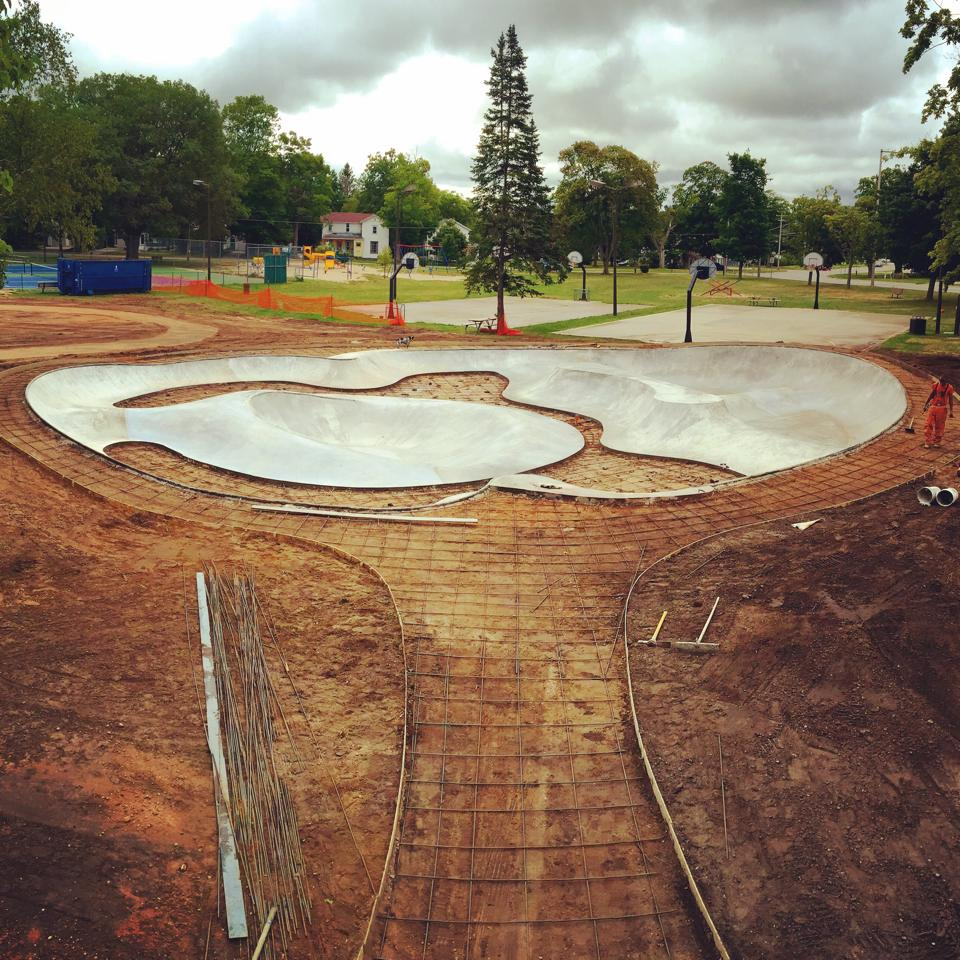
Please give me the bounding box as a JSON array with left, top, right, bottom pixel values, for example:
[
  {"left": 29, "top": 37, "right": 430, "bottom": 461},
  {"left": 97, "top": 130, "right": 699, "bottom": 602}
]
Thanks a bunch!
[{"left": 0, "top": 0, "right": 960, "bottom": 298}]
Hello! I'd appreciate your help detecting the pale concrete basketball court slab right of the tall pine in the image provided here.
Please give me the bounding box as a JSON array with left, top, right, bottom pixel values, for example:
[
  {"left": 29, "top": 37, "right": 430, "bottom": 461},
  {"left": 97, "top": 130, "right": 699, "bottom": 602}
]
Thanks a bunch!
[{"left": 562, "top": 302, "right": 910, "bottom": 347}]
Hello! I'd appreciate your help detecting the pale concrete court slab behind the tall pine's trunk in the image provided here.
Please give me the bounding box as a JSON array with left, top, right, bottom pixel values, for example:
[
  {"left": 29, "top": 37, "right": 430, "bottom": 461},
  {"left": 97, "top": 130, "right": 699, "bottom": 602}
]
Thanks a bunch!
[{"left": 338, "top": 297, "right": 639, "bottom": 328}]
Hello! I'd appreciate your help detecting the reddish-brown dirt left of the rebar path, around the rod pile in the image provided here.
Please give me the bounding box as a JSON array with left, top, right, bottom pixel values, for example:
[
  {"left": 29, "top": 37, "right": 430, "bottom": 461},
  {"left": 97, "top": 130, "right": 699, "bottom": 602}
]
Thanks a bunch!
[{"left": 0, "top": 445, "right": 403, "bottom": 960}]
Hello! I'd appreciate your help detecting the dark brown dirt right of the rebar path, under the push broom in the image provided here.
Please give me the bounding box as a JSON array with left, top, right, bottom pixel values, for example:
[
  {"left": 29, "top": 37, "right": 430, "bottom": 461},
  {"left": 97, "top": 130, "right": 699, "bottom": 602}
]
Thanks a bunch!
[{"left": 629, "top": 472, "right": 960, "bottom": 960}]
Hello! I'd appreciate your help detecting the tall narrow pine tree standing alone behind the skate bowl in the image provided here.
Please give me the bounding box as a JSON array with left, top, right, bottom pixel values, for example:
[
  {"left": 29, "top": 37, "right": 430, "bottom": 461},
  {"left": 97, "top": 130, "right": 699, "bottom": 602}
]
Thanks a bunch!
[{"left": 467, "top": 24, "right": 565, "bottom": 333}]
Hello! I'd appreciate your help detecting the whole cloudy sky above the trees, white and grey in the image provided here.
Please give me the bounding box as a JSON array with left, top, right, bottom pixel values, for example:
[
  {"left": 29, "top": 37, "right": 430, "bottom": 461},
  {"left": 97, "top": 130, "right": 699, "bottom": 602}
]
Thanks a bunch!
[{"left": 33, "top": 0, "right": 960, "bottom": 197}]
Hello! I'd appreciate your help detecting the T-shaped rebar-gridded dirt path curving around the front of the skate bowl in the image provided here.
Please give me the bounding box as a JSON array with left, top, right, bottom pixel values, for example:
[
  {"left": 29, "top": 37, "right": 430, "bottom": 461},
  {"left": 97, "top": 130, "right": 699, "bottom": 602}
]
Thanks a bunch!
[{"left": 0, "top": 342, "right": 948, "bottom": 960}]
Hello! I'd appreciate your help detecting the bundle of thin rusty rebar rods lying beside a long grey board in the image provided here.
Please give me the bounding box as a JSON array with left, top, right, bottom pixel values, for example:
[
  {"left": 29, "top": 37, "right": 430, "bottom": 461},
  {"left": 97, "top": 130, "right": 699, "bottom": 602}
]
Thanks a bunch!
[{"left": 205, "top": 566, "right": 311, "bottom": 958}]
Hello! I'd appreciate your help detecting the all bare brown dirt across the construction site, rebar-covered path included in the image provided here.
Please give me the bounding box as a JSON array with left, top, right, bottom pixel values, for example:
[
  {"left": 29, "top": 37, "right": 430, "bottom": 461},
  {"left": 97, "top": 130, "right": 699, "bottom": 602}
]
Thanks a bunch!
[{"left": 0, "top": 297, "right": 960, "bottom": 960}]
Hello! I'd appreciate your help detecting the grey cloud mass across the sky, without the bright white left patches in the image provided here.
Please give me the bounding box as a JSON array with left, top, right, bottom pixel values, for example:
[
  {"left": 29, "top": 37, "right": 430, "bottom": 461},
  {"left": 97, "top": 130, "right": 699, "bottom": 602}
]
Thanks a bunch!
[{"left": 62, "top": 0, "right": 949, "bottom": 201}]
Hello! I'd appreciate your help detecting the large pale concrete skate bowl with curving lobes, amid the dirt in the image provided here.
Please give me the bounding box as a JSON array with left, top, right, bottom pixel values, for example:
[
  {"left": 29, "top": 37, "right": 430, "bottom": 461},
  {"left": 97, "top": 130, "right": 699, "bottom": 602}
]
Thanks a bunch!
[{"left": 26, "top": 347, "right": 906, "bottom": 496}]
